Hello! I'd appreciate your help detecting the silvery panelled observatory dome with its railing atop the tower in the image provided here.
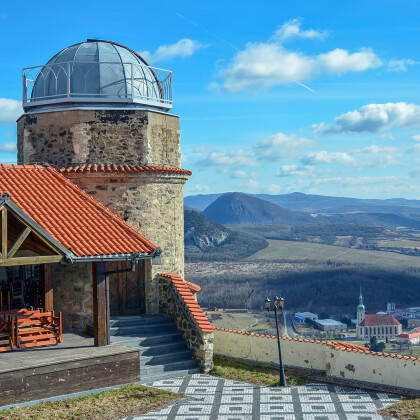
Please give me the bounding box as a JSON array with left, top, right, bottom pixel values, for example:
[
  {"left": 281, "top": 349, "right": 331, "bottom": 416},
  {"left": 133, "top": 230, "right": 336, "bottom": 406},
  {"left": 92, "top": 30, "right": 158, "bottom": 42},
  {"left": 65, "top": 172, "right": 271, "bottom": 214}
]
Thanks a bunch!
[{"left": 23, "top": 39, "right": 172, "bottom": 110}]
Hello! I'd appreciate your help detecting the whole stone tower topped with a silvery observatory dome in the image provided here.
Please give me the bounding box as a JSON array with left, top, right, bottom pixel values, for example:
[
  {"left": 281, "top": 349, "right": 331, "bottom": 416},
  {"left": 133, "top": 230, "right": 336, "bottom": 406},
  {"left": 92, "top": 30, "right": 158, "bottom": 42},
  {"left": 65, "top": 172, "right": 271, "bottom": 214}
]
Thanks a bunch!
[{"left": 18, "top": 39, "right": 191, "bottom": 313}]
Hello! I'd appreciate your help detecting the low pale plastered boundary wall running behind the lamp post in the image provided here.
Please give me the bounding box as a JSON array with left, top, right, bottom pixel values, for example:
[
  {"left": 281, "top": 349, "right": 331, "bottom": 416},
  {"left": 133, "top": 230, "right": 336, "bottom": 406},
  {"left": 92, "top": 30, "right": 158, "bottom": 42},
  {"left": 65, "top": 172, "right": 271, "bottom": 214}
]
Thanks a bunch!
[{"left": 214, "top": 329, "right": 420, "bottom": 391}]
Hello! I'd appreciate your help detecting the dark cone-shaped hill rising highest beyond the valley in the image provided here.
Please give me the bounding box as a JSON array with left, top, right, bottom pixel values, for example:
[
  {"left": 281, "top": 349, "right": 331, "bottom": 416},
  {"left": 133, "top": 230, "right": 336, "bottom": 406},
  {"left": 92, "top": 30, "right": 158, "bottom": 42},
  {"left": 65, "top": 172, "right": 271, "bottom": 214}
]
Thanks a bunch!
[{"left": 203, "top": 193, "right": 314, "bottom": 226}]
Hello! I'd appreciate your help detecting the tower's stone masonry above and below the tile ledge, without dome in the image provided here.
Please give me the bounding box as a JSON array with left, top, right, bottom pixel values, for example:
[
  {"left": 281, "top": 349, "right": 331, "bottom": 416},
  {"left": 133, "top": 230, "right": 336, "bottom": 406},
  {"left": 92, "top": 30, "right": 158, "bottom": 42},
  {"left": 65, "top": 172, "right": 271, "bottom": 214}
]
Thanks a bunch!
[{"left": 18, "top": 109, "right": 188, "bottom": 313}]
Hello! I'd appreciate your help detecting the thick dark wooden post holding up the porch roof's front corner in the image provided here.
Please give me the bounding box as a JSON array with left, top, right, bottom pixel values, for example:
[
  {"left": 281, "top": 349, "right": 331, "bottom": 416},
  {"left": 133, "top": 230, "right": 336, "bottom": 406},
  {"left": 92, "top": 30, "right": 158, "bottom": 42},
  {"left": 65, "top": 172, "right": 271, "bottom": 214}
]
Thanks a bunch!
[{"left": 92, "top": 262, "right": 109, "bottom": 347}]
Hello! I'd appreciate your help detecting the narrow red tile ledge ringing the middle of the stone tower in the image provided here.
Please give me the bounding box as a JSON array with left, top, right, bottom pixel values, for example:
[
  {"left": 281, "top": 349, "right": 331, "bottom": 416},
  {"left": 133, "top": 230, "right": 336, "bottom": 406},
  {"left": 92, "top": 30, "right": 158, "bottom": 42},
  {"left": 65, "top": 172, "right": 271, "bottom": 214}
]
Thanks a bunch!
[{"left": 58, "top": 164, "right": 192, "bottom": 175}]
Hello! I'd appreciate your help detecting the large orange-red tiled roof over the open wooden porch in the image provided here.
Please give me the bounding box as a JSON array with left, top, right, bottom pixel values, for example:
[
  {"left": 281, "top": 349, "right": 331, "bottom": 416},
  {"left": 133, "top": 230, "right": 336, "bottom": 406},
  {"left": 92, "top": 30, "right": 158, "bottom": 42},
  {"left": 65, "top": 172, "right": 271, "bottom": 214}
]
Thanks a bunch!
[{"left": 0, "top": 164, "right": 157, "bottom": 257}]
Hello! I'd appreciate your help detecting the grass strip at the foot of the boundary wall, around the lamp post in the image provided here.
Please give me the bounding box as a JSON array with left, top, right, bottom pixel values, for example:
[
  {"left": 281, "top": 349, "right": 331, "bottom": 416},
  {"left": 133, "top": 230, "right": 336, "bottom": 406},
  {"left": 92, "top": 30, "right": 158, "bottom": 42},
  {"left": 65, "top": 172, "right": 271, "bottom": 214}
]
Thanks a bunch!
[{"left": 211, "top": 356, "right": 312, "bottom": 386}]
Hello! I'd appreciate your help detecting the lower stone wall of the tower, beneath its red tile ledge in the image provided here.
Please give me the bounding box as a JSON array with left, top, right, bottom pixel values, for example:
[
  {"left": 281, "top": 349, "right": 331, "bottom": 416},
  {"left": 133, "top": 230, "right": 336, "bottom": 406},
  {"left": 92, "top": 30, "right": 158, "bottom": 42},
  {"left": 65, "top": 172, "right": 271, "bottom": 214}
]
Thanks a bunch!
[{"left": 65, "top": 173, "right": 188, "bottom": 313}]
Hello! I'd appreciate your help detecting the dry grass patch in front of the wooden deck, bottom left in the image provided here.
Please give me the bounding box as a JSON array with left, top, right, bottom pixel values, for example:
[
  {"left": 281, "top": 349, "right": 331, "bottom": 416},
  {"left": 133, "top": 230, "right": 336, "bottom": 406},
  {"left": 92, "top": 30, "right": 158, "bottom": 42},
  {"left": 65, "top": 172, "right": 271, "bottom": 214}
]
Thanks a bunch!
[{"left": 0, "top": 384, "right": 184, "bottom": 420}]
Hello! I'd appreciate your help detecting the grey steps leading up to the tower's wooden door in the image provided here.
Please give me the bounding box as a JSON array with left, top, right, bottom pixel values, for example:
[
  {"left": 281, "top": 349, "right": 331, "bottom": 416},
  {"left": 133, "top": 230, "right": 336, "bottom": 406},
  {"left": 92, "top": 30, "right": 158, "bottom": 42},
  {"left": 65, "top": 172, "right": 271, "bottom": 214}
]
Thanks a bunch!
[{"left": 111, "top": 315, "right": 200, "bottom": 383}]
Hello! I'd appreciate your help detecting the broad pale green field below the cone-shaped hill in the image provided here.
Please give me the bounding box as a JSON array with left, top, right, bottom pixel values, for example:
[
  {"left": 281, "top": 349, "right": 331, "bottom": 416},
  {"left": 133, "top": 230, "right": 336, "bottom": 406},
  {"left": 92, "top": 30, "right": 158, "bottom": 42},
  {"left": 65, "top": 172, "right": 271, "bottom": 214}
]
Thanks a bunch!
[{"left": 247, "top": 240, "right": 420, "bottom": 267}]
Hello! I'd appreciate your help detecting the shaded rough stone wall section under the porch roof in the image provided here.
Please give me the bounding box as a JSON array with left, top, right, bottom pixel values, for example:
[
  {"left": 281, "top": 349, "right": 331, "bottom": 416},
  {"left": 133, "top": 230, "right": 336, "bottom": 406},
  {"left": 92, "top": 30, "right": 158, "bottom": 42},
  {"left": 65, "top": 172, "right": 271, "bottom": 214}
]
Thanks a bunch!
[{"left": 52, "top": 263, "right": 93, "bottom": 332}]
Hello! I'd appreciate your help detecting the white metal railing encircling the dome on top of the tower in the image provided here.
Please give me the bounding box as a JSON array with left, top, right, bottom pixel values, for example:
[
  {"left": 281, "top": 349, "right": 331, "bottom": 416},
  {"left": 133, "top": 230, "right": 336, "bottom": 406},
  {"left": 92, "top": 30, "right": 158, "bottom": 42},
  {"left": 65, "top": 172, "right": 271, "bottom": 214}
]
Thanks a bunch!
[{"left": 22, "top": 61, "right": 172, "bottom": 108}]
